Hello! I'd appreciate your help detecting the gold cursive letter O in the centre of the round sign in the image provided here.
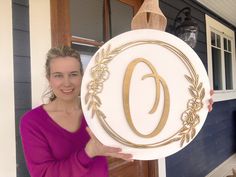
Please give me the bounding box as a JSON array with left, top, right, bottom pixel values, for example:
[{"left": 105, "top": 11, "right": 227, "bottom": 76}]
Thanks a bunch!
[{"left": 123, "top": 58, "right": 170, "bottom": 138}]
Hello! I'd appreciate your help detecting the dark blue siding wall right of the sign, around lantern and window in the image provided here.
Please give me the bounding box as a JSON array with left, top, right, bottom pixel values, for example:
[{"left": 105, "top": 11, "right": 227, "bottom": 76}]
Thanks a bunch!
[{"left": 160, "top": 0, "right": 236, "bottom": 177}]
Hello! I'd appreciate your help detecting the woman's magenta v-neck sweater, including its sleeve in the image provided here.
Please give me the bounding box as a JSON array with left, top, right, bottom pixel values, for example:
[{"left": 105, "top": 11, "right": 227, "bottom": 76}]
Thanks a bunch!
[{"left": 20, "top": 105, "right": 108, "bottom": 177}]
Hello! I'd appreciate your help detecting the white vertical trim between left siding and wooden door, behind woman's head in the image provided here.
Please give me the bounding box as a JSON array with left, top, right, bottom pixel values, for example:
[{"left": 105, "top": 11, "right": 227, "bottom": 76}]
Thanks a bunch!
[{"left": 29, "top": 0, "right": 51, "bottom": 107}]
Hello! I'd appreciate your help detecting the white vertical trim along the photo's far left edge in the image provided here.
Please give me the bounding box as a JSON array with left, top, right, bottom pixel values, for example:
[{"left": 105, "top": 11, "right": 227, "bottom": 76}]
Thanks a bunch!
[{"left": 0, "top": 0, "right": 16, "bottom": 177}]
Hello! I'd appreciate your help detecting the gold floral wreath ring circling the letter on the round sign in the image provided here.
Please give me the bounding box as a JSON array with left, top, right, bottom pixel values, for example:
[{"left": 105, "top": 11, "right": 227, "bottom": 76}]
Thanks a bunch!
[{"left": 85, "top": 40, "right": 205, "bottom": 148}]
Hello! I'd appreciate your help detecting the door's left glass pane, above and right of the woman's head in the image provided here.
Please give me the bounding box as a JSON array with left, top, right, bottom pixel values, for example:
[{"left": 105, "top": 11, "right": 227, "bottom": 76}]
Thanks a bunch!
[{"left": 70, "top": 0, "right": 103, "bottom": 41}]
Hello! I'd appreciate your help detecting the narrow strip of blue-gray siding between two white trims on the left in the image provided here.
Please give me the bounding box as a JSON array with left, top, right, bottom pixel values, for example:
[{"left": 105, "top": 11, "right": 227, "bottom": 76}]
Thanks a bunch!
[{"left": 12, "top": 0, "right": 31, "bottom": 177}]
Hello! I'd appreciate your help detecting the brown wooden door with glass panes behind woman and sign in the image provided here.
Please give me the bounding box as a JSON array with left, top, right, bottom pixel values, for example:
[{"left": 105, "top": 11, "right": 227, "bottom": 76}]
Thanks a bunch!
[{"left": 51, "top": 0, "right": 158, "bottom": 177}]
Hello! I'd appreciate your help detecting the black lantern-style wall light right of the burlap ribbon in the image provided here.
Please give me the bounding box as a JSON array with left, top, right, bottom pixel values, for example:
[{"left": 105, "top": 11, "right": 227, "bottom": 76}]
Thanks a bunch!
[{"left": 174, "top": 7, "right": 198, "bottom": 48}]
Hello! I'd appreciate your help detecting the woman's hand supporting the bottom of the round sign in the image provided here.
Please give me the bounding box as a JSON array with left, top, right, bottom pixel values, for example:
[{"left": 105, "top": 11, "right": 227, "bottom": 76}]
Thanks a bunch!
[{"left": 85, "top": 127, "right": 133, "bottom": 161}]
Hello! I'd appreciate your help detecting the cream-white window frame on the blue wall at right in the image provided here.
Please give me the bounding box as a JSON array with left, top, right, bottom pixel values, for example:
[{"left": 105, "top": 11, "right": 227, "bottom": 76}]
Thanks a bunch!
[{"left": 205, "top": 14, "right": 236, "bottom": 102}]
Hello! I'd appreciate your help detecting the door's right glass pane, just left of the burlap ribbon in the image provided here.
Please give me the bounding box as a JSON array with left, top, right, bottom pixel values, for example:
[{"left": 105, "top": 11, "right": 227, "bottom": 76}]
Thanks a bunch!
[{"left": 110, "top": 0, "right": 133, "bottom": 37}]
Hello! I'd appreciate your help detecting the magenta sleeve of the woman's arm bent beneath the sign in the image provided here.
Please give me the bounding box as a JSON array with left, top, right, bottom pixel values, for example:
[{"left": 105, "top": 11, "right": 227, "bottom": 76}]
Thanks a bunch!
[{"left": 20, "top": 117, "right": 92, "bottom": 177}]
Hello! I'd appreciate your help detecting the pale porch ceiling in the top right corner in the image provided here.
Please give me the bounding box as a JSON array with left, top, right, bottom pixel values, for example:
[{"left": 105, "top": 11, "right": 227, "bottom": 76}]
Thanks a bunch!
[{"left": 197, "top": 0, "right": 236, "bottom": 27}]
